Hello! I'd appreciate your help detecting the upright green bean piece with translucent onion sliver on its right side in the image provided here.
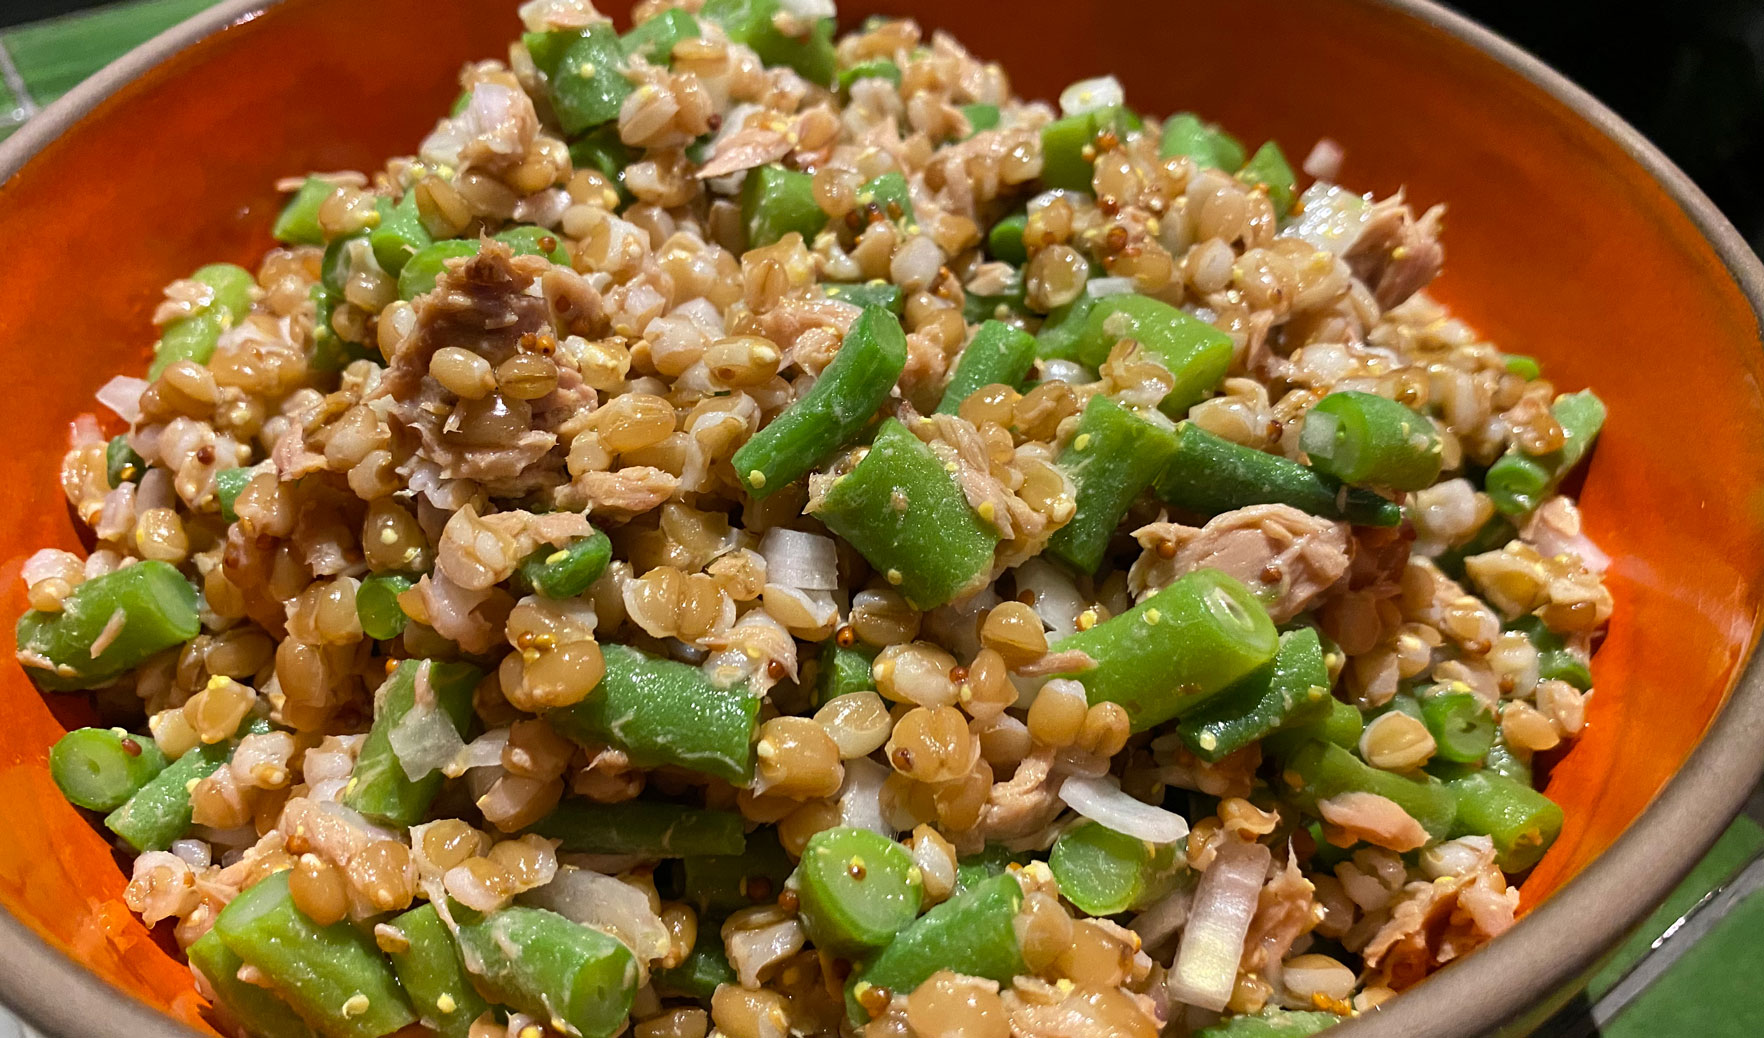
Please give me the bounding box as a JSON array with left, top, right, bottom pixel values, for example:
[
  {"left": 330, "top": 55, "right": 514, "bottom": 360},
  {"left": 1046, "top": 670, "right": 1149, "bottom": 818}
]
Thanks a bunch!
[{"left": 342, "top": 660, "right": 483, "bottom": 826}]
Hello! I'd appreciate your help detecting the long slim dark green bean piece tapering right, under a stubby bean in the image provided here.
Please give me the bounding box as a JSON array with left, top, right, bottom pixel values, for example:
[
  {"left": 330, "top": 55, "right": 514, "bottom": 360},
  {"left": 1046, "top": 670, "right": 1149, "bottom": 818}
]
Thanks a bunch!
[{"left": 1154, "top": 422, "right": 1402, "bottom": 526}]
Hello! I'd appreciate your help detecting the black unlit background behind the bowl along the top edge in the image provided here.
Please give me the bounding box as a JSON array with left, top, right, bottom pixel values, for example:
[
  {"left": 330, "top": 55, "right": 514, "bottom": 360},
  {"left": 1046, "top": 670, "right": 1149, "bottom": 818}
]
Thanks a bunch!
[{"left": 0, "top": 0, "right": 1764, "bottom": 251}]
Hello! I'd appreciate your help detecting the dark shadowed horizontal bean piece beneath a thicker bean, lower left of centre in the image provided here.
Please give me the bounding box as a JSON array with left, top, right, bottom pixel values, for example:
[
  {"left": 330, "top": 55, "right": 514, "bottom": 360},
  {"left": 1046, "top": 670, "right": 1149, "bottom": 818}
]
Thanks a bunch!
[{"left": 531, "top": 800, "right": 748, "bottom": 858}]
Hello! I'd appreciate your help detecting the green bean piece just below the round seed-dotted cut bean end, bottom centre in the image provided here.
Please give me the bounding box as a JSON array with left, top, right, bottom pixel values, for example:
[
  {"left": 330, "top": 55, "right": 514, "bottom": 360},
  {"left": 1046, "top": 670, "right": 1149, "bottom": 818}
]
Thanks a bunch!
[{"left": 845, "top": 876, "right": 1028, "bottom": 1026}]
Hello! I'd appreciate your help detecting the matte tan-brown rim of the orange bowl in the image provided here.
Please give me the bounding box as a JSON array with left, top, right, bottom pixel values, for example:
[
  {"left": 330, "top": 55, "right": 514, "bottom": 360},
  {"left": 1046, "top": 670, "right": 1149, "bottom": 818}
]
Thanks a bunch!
[{"left": 0, "top": 0, "right": 1764, "bottom": 1038}]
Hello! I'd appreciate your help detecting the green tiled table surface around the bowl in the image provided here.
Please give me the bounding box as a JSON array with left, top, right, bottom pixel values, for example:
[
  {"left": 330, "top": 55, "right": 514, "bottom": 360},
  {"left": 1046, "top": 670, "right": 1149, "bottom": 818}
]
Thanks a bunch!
[{"left": 0, "top": 0, "right": 1764, "bottom": 1038}]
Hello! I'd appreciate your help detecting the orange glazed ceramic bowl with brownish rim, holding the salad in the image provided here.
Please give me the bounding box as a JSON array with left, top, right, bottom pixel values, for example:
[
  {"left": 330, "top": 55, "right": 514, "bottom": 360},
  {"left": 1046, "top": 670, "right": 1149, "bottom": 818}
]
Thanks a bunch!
[{"left": 0, "top": 0, "right": 1764, "bottom": 1038}]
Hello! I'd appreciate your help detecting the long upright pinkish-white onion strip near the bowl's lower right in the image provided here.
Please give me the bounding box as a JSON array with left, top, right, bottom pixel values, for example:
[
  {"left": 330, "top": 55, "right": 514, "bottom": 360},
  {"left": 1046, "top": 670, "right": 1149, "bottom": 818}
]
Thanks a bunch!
[{"left": 1164, "top": 839, "right": 1274, "bottom": 1012}]
